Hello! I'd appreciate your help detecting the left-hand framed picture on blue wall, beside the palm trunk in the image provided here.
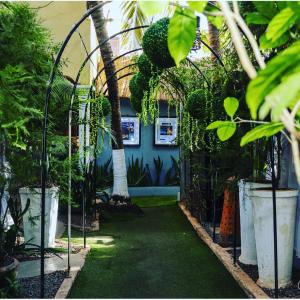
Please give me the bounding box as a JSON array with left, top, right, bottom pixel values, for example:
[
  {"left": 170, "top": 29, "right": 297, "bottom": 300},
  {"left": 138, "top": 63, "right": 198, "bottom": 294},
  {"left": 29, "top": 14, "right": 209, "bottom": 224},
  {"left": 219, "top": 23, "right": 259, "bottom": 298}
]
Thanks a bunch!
[{"left": 121, "top": 117, "right": 140, "bottom": 146}]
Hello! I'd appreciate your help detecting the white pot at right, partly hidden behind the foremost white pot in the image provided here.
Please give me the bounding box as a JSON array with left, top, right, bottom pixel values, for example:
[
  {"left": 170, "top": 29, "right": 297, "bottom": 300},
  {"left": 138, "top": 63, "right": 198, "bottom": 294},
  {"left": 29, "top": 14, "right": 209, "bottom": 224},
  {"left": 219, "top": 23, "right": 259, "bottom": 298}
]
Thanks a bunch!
[{"left": 238, "top": 179, "right": 271, "bottom": 265}]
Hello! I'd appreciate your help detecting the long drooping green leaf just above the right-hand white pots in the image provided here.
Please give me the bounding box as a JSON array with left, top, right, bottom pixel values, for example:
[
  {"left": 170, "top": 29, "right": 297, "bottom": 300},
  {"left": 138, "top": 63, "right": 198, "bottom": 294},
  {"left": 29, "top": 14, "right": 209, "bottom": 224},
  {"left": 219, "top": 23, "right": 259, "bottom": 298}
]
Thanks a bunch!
[{"left": 241, "top": 123, "right": 284, "bottom": 147}]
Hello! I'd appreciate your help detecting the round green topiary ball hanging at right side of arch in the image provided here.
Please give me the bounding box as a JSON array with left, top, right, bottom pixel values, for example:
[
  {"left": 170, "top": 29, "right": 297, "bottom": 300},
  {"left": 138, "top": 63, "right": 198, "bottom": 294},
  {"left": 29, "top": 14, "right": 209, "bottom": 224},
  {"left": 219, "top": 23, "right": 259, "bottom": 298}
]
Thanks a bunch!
[{"left": 185, "top": 89, "right": 206, "bottom": 120}]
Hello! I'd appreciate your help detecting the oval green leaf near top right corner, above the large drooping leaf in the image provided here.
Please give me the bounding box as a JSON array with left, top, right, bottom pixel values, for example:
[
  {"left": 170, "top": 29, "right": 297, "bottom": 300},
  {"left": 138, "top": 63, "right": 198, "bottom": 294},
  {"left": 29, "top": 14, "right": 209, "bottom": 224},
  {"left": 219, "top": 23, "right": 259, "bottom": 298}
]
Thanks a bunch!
[{"left": 266, "top": 7, "right": 297, "bottom": 42}]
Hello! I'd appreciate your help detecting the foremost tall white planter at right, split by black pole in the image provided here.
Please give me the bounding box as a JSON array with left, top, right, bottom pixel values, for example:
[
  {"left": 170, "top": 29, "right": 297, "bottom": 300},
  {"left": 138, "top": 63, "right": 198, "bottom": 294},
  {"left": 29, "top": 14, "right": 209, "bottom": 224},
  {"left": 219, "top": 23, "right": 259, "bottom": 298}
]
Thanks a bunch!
[{"left": 252, "top": 189, "right": 298, "bottom": 288}]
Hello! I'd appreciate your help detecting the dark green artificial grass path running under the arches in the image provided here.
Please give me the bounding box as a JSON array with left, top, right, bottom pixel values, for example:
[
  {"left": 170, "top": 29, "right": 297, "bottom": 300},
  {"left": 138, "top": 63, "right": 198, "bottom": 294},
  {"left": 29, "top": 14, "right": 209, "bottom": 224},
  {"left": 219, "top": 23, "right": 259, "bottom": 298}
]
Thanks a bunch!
[{"left": 70, "top": 199, "right": 246, "bottom": 298}]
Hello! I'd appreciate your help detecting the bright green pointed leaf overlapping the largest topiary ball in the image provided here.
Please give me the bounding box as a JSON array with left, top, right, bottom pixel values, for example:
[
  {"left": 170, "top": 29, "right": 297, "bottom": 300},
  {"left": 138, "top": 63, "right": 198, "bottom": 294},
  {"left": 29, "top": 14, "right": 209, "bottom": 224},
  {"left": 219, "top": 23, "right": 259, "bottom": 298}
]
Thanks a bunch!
[{"left": 168, "top": 8, "right": 197, "bottom": 66}]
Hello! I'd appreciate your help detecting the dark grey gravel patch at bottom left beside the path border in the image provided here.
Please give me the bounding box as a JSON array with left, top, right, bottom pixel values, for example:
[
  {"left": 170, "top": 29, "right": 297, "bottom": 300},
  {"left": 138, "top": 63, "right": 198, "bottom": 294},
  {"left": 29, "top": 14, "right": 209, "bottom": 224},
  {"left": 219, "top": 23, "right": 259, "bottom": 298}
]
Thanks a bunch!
[{"left": 18, "top": 271, "right": 67, "bottom": 299}]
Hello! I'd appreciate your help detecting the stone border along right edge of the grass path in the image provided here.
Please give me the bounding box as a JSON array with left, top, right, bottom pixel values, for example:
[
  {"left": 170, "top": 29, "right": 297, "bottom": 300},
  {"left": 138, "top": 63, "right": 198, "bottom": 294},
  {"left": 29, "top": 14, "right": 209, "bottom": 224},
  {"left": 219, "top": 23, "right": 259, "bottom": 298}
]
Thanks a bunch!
[{"left": 178, "top": 202, "right": 270, "bottom": 299}]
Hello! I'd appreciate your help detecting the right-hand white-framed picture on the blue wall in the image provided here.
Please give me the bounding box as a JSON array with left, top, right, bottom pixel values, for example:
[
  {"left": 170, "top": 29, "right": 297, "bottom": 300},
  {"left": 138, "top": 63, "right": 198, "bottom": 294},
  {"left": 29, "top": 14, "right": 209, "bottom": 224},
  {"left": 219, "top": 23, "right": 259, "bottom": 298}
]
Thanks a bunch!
[{"left": 154, "top": 118, "right": 178, "bottom": 146}]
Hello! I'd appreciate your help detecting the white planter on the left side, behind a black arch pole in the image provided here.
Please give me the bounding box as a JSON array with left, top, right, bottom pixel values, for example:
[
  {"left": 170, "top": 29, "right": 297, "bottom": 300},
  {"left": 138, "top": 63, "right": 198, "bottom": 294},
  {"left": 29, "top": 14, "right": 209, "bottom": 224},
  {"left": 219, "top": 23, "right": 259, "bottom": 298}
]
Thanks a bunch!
[{"left": 19, "top": 187, "right": 59, "bottom": 248}]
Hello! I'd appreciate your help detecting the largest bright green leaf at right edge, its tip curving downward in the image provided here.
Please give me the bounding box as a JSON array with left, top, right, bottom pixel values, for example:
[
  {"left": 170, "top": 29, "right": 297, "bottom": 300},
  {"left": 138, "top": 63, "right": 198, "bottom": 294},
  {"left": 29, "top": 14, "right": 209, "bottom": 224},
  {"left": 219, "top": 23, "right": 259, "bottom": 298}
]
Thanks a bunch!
[{"left": 246, "top": 41, "right": 300, "bottom": 119}]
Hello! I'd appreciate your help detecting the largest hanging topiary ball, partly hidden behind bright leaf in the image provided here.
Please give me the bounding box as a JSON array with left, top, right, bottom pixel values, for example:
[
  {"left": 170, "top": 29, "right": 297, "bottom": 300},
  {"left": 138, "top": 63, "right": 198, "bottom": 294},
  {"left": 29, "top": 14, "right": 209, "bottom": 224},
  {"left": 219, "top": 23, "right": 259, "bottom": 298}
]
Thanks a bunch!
[{"left": 143, "top": 18, "right": 175, "bottom": 68}]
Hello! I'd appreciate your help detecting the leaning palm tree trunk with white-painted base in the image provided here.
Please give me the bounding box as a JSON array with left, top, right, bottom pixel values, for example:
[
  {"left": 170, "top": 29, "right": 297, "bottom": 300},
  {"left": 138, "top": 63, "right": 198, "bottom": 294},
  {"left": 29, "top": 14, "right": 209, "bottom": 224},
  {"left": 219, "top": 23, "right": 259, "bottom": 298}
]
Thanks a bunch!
[{"left": 87, "top": 1, "right": 130, "bottom": 202}]
